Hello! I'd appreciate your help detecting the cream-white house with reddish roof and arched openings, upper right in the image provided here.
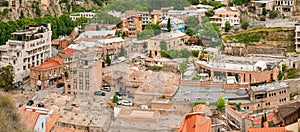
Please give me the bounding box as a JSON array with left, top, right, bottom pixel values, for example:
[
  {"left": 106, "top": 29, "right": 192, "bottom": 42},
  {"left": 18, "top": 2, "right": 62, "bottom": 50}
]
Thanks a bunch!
[{"left": 210, "top": 7, "right": 240, "bottom": 28}]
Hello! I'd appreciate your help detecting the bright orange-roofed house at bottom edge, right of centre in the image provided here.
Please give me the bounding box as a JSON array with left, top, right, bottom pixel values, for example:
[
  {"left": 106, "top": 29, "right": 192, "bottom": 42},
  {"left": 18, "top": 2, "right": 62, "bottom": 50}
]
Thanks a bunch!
[{"left": 178, "top": 112, "right": 212, "bottom": 132}]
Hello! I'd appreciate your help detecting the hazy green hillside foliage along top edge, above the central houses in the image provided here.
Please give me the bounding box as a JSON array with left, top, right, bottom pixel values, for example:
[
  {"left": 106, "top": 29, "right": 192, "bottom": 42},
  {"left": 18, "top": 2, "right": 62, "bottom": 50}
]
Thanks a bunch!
[{"left": 102, "top": 0, "right": 190, "bottom": 12}]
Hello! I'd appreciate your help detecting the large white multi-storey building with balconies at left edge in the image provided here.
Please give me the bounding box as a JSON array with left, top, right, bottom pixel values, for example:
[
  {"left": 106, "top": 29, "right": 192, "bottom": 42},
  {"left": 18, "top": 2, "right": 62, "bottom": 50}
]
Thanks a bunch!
[{"left": 0, "top": 24, "right": 52, "bottom": 82}]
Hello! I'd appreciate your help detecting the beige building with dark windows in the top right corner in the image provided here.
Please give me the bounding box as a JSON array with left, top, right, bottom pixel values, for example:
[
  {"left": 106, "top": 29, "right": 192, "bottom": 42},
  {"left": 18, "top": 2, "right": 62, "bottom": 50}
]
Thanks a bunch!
[{"left": 274, "top": 0, "right": 297, "bottom": 16}]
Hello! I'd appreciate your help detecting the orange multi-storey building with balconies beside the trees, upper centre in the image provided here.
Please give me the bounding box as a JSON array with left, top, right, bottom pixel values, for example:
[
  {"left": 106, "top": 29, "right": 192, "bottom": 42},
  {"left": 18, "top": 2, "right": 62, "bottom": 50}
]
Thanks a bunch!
[{"left": 121, "top": 10, "right": 142, "bottom": 38}]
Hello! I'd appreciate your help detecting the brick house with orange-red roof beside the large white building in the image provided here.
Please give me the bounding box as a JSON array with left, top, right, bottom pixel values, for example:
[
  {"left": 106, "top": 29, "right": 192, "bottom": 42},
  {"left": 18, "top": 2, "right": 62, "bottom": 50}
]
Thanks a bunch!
[{"left": 30, "top": 56, "right": 64, "bottom": 89}]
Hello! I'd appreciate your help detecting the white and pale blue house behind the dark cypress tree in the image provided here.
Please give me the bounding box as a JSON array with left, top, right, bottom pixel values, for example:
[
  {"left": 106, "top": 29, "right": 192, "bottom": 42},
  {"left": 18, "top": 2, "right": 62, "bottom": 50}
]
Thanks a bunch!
[{"left": 159, "top": 17, "right": 185, "bottom": 32}]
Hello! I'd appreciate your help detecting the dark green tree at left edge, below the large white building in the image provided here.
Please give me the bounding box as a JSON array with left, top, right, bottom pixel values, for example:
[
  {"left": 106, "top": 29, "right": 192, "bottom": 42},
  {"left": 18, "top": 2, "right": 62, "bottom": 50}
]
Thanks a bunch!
[{"left": 0, "top": 65, "right": 14, "bottom": 91}]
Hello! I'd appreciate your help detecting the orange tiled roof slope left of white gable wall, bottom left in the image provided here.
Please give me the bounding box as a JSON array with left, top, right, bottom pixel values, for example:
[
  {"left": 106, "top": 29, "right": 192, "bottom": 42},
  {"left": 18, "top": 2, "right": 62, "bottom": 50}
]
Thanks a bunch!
[{"left": 18, "top": 109, "right": 40, "bottom": 131}]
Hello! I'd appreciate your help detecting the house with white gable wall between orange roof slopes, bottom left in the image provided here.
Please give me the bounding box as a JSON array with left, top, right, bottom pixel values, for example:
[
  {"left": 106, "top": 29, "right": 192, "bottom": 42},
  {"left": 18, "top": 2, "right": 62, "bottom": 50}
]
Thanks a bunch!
[{"left": 18, "top": 106, "right": 60, "bottom": 132}]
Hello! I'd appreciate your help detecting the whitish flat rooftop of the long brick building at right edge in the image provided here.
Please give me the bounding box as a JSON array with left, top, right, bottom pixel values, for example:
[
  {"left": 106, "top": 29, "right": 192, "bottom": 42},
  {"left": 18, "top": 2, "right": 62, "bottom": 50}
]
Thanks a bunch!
[{"left": 251, "top": 82, "right": 289, "bottom": 92}]
